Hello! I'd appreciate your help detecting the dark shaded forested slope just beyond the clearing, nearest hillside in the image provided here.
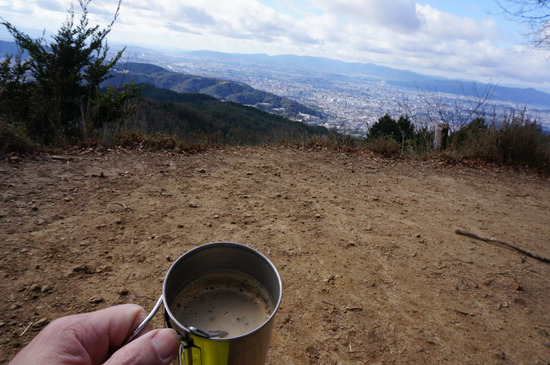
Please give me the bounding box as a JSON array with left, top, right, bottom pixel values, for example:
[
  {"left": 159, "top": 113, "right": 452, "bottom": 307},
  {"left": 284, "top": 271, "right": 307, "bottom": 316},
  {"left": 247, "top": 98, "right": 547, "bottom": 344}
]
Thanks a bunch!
[{"left": 125, "top": 84, "right": 329, "bottom": 145}]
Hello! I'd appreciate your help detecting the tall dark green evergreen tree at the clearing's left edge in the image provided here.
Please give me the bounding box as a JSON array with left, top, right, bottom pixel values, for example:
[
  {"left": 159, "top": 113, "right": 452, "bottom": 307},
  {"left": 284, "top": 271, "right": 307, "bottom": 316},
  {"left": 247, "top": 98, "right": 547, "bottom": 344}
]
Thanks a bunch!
[{"left": 0, "top": 0, "right": 137, "bottom": 145}]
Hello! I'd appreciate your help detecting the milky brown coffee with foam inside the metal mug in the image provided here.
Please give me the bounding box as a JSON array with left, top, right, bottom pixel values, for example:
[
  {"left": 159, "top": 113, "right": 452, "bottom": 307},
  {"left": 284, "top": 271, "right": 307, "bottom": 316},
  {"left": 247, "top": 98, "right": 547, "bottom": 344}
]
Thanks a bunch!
[{"left": 171, "top": 272, "right": 274, "bottom": 337}]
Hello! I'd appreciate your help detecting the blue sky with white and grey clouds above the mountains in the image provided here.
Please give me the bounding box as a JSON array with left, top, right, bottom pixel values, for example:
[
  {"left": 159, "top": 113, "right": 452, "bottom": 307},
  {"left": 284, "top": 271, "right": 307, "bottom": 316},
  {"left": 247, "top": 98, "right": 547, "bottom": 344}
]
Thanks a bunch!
[{"left": 0, "top": 0, "right": 550, "bottom": 91}]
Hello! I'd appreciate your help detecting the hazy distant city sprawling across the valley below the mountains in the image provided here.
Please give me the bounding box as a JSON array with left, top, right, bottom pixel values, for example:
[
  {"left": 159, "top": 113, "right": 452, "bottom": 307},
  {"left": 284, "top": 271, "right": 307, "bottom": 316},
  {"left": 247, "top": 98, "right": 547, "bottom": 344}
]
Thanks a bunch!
[{"left": 130, "top": 47, "right": 550, "bottom": 137}]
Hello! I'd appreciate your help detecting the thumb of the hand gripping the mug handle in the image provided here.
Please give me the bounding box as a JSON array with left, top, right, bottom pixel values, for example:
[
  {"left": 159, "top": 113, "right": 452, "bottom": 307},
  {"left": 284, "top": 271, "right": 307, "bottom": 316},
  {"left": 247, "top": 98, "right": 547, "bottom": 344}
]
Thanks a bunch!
[{"left": 104, "top": 328, "right": 180, "bottom": 365}]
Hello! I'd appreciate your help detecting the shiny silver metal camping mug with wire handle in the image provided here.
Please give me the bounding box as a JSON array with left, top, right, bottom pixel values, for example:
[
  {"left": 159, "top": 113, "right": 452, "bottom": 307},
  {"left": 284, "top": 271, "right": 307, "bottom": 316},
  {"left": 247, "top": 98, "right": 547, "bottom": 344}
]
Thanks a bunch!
[{"left": 127, "top": 242, "right": 282, "bottom": 365}]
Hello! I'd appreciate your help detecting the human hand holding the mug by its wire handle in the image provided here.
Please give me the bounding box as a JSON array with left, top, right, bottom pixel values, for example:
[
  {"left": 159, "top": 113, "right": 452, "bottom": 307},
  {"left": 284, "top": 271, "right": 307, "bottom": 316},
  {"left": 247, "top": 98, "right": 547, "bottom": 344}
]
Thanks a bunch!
[{"left": 9, "top": 304, "right": 179, "bottom": 365}]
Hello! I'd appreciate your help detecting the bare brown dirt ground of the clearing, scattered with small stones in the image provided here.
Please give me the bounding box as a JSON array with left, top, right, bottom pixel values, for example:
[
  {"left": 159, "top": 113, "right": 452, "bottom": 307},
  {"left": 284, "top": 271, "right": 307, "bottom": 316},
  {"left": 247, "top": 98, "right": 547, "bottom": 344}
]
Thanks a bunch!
[{"left": 0, "top": 147, "right": 550, "bottom": 364}]
